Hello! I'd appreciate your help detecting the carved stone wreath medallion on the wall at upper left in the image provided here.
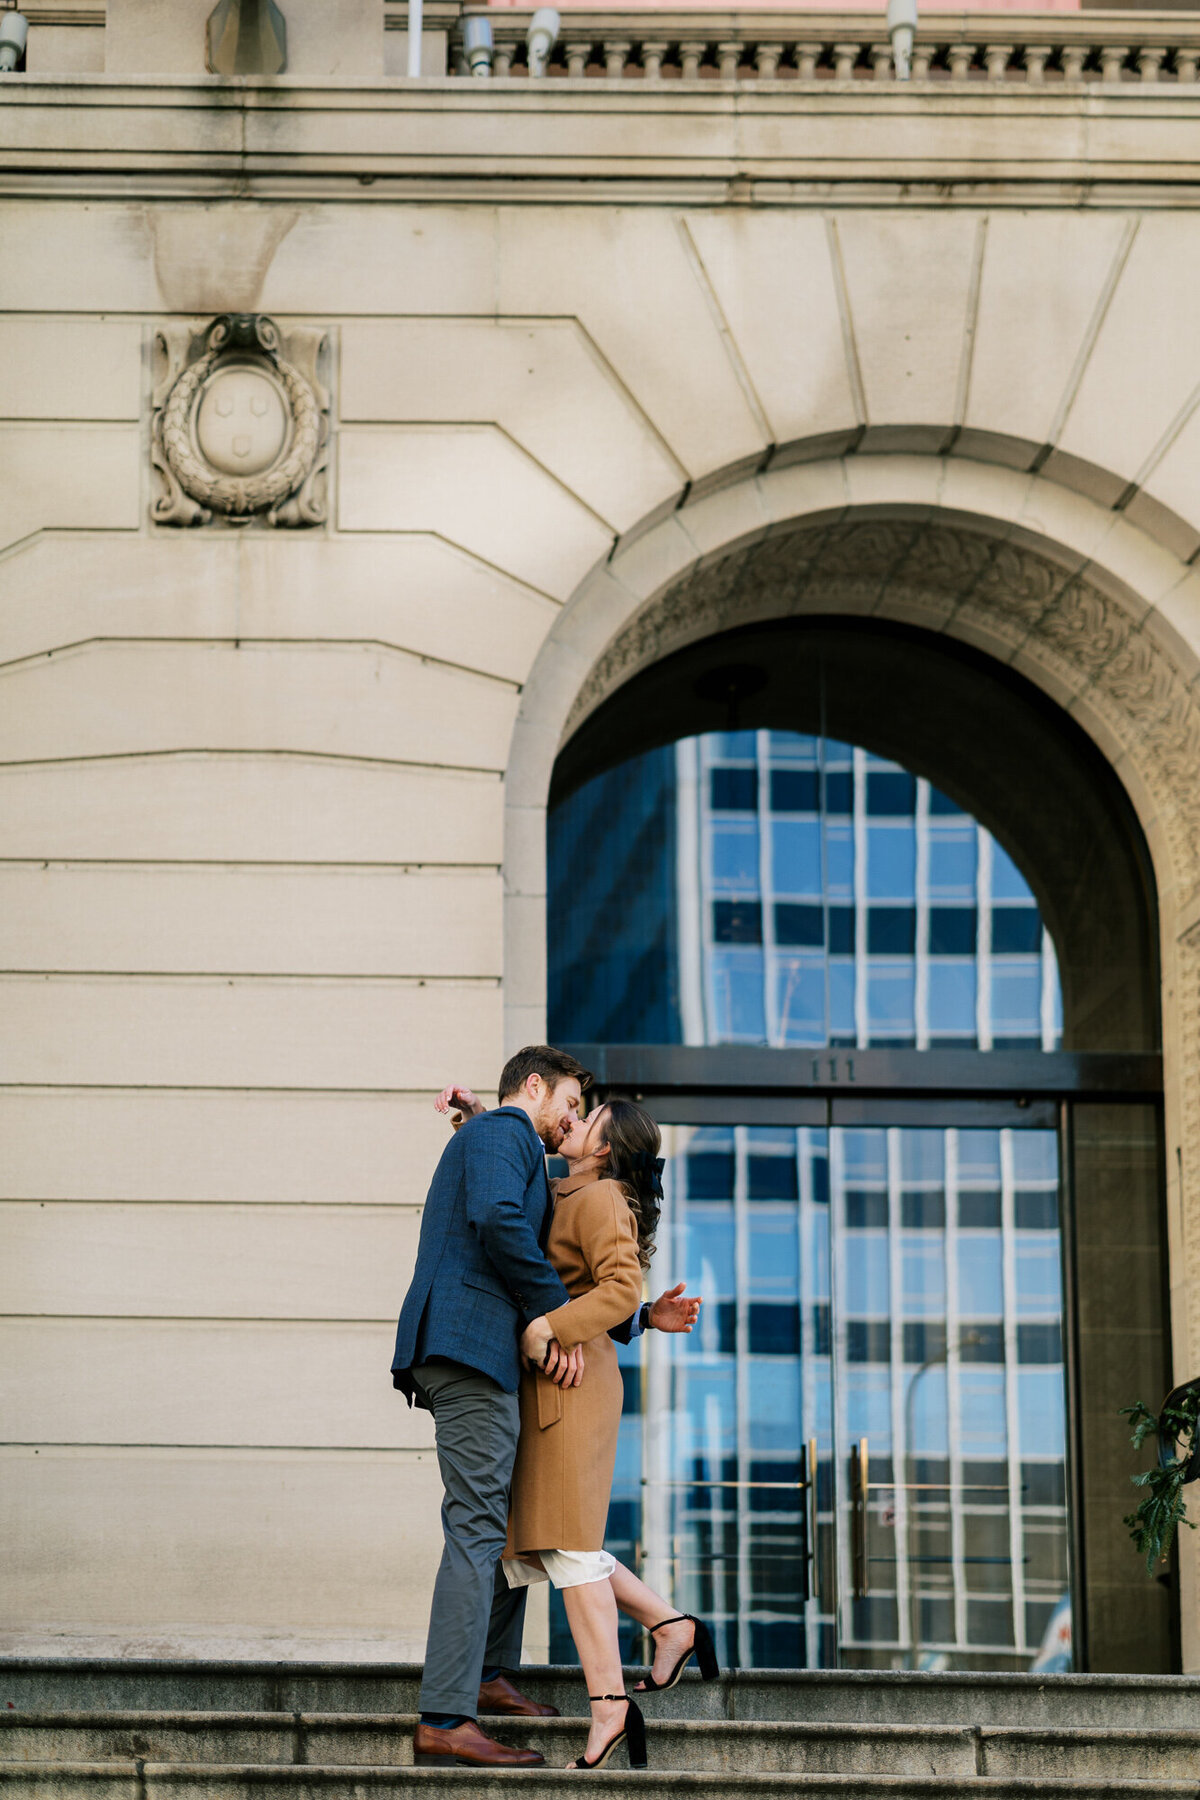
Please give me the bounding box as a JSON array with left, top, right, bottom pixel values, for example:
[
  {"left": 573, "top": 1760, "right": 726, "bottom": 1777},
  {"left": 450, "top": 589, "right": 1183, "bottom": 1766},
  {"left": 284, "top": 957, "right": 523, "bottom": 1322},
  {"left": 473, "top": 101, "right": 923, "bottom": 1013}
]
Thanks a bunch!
[{"left": 151, "top": 313, "right": 329, "bottom": 526}]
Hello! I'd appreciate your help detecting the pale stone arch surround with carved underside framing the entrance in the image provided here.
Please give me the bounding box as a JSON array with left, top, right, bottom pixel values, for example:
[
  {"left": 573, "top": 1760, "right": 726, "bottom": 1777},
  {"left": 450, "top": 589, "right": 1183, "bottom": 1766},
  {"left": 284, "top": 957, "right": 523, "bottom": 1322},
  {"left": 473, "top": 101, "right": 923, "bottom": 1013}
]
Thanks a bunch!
[{"left": 506, "top": 455, "right": 1200, "bottom": 1440}]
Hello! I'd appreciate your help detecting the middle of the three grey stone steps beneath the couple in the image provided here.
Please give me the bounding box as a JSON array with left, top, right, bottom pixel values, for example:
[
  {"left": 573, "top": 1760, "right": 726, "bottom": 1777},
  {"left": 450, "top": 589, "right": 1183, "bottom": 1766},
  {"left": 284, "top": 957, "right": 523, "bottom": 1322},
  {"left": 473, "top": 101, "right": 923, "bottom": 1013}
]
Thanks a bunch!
[{"left": 0, "top": 1708, "right": 1200, "bottom": 1787}]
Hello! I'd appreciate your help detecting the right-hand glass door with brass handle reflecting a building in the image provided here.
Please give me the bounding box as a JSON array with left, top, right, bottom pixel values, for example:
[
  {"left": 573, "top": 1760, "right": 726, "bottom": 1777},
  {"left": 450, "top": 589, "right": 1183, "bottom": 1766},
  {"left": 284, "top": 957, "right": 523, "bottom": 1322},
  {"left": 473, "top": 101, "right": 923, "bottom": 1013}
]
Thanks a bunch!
[{"left": 829, "top": 1107, "right": 1070, "bottom": 1670}]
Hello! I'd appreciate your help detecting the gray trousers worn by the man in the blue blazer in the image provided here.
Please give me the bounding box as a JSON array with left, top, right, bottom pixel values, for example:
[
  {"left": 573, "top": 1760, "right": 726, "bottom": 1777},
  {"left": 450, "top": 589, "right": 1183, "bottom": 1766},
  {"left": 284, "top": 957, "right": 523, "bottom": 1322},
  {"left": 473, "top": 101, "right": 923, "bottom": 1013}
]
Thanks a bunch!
[{"left": 412, "top": 1363, "right": 525, "bottom": 1719}]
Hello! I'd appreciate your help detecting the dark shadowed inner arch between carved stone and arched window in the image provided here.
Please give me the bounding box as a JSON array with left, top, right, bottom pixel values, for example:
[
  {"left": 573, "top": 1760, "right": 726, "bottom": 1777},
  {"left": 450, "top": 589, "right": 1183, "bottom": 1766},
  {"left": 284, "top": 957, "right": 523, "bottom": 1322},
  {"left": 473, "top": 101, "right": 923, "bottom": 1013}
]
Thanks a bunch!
[{"left": 549, "top": 615, "right": 1160, "bottom": 1051}]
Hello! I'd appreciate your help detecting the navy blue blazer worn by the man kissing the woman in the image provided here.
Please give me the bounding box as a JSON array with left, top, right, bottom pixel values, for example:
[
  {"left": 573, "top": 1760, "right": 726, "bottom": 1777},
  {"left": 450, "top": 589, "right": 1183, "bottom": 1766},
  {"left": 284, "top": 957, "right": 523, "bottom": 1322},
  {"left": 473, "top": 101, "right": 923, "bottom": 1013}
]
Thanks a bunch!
[{"left": 392, "top": 1107, "right": 570, "bottom": 1406}]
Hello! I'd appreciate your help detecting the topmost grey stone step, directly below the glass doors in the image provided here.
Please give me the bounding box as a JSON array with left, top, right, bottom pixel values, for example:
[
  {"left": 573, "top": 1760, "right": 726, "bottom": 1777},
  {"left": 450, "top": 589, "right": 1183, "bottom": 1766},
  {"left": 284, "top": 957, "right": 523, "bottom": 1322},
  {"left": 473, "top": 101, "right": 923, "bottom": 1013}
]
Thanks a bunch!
[{"left": 0, "top": 1658, "right": 1200, "bottom": 1730}]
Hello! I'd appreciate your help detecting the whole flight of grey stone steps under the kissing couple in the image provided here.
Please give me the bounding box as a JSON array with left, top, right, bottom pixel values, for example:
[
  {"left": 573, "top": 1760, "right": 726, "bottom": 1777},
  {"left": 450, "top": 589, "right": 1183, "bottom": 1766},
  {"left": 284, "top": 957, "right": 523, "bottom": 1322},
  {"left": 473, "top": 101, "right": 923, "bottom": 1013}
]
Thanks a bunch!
[{"left": 0, "top": 1658, "right": 1200, "bottom": 1800}]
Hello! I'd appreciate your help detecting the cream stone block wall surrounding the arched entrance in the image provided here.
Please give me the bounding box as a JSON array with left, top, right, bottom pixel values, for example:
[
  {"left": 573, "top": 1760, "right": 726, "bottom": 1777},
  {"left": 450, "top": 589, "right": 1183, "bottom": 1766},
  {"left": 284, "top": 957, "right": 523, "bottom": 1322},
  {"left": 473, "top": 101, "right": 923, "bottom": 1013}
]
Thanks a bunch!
[{"left": 0, "top": 83, "right": 1200, "bottom": 1663}]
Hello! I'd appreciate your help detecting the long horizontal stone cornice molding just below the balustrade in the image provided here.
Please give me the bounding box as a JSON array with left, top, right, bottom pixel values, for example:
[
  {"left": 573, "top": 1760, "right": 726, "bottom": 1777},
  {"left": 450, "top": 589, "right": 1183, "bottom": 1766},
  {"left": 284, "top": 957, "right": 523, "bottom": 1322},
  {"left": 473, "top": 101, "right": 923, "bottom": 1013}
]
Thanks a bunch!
[{"left": 11, "top": 76, "right": 1200, "bottom": 207}]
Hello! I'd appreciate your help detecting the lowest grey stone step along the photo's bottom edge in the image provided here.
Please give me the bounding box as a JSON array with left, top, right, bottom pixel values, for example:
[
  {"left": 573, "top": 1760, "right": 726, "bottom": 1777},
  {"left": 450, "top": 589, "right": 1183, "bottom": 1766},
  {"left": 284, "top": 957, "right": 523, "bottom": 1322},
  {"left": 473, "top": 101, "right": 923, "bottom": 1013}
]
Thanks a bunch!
[{"left": 0, "top": 1759, "right": 1196, "bottom": 1800}]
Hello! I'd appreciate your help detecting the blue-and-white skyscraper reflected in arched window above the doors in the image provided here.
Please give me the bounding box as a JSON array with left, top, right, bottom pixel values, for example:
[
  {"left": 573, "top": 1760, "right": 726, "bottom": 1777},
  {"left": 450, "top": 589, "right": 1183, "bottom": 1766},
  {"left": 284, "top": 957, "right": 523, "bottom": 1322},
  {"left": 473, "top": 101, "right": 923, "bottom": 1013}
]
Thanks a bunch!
[{"left": 676, "top": 731, "right": 1061, "bottom": 1049}]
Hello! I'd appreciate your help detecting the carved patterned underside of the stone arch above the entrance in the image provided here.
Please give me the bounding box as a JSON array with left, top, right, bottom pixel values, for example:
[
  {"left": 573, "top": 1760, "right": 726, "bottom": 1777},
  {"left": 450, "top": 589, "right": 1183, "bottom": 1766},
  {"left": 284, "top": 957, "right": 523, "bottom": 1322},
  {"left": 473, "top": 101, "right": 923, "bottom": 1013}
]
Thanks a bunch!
[{"left": 563, "top": 517, "right": 1200, "bottom": 902}]
